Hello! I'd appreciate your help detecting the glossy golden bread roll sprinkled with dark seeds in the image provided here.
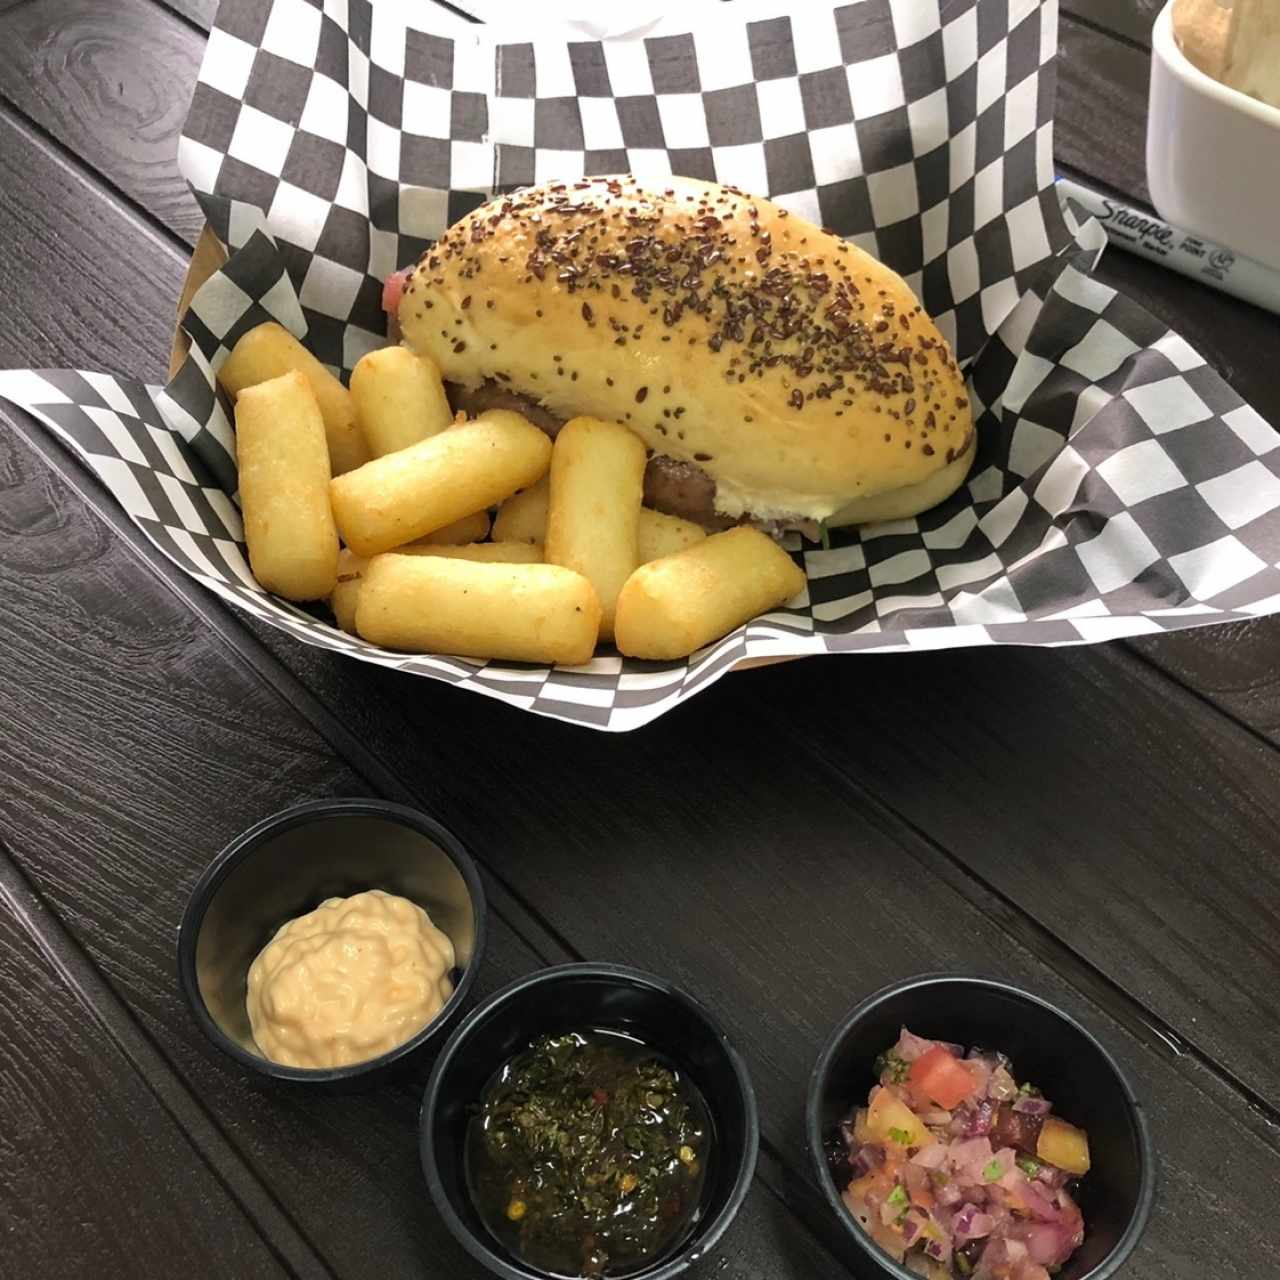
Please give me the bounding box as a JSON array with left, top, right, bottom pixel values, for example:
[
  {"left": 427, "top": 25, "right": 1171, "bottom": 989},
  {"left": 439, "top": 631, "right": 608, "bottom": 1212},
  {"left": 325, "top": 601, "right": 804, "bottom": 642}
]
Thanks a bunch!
[{"left": 398, "top": 177, "right": 973, "bottom": 521}]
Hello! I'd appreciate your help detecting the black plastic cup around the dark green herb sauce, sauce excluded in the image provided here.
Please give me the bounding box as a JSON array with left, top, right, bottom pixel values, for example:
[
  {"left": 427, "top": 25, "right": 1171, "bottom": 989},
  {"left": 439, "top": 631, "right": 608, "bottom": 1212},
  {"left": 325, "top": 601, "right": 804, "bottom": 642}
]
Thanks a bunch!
[{"left": 421, "top": 964, "right": 759, "bottom": 1280}]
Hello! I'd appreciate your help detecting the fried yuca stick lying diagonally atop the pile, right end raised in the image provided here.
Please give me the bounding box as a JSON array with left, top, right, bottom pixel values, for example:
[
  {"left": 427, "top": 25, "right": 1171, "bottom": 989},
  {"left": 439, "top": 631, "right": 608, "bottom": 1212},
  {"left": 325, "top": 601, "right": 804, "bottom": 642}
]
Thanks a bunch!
[{"left": 329, "top": 410, "right": 552, "bottom": 556}]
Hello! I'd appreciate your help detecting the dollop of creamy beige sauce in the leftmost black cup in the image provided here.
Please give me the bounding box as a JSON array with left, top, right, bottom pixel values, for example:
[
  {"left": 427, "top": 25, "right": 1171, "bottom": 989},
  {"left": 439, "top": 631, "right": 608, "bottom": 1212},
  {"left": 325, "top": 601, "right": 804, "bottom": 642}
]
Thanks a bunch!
[{"left": 247, "top": 888, "right": 454, "bottom": 1068}]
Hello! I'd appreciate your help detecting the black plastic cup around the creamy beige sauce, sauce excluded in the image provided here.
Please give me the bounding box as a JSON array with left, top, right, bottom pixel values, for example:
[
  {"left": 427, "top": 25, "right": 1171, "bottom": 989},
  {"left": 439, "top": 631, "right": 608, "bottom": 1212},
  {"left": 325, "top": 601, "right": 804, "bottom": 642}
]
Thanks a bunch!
[{"left": 178, "top": 800, "right": 485, "bottom": 1092}]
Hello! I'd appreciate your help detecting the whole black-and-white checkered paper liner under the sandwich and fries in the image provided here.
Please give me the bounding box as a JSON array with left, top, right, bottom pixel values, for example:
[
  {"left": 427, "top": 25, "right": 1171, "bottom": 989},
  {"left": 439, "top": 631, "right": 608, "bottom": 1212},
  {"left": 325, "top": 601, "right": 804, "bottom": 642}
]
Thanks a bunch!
[{"left": 0, "top": 0, "right": 1280, "bottom": 730}]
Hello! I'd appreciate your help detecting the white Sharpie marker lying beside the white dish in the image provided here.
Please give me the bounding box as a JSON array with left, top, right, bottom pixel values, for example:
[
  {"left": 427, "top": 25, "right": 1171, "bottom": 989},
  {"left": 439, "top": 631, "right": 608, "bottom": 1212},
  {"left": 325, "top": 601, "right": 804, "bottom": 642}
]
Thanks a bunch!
[{"left": 1057, "top": 178, "right": 1280, "bottom": 315}]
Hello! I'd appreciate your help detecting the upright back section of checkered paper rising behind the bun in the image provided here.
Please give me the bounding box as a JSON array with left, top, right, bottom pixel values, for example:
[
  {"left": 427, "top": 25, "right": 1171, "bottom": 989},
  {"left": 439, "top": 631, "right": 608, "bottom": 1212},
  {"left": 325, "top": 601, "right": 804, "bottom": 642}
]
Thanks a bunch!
[{"left": 179, "top": 0, "right": 1062, "bottom": 370}]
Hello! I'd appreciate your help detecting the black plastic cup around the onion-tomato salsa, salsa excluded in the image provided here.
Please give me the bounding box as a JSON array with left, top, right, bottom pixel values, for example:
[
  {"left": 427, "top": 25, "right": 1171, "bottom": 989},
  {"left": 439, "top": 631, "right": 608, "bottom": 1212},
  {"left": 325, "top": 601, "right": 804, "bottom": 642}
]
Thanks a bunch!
[{"left": 805, "top": 974, "right": 1156, "bottom": 1280}]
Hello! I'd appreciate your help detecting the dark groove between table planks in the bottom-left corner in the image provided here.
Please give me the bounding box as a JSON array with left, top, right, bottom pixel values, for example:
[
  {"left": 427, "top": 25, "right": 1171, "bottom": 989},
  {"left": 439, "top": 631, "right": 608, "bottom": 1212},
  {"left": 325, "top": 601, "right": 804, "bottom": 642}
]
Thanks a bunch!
[{"left": 0, "top": 840, "right": 334, "bottom": 1277}]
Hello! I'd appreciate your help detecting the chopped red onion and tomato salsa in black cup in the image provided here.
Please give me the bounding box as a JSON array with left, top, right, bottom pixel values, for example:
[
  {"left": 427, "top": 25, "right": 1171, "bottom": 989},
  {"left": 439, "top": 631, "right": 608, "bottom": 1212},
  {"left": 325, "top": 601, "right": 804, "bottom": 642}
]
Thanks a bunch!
[{"left": 828, "top": 1028, "right": 1089, "bottom": 1280}]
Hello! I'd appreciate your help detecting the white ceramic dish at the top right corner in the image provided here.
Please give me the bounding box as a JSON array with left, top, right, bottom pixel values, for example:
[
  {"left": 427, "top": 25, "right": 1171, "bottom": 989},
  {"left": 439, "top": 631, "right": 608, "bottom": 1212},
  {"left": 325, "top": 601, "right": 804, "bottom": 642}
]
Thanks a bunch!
[{"left": 1147, "top": 0, "right": 1280, "bottom": 269}]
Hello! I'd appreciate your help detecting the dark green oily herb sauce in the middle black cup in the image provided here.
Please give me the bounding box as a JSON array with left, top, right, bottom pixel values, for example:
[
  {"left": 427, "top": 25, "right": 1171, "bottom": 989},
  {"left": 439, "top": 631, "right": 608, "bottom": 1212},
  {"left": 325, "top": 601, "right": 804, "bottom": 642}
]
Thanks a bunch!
[{"left": 466, "top": 1032, "right": 712, "bottom": 1276}]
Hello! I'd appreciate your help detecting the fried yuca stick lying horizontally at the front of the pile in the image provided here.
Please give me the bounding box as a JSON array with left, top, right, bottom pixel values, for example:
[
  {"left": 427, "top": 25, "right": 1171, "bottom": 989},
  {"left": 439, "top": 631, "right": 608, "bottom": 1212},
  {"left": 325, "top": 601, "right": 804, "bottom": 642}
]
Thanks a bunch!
[{"left": 356, "top": 553, "right": 600, "bottom": 666}]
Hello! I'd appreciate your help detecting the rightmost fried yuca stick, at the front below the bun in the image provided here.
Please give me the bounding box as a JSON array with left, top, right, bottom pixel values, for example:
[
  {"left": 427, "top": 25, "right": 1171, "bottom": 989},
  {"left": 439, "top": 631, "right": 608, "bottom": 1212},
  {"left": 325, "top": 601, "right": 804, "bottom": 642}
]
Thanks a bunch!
[{"left": 614, "top": 527, "right": 805, "bottom": 659}]
